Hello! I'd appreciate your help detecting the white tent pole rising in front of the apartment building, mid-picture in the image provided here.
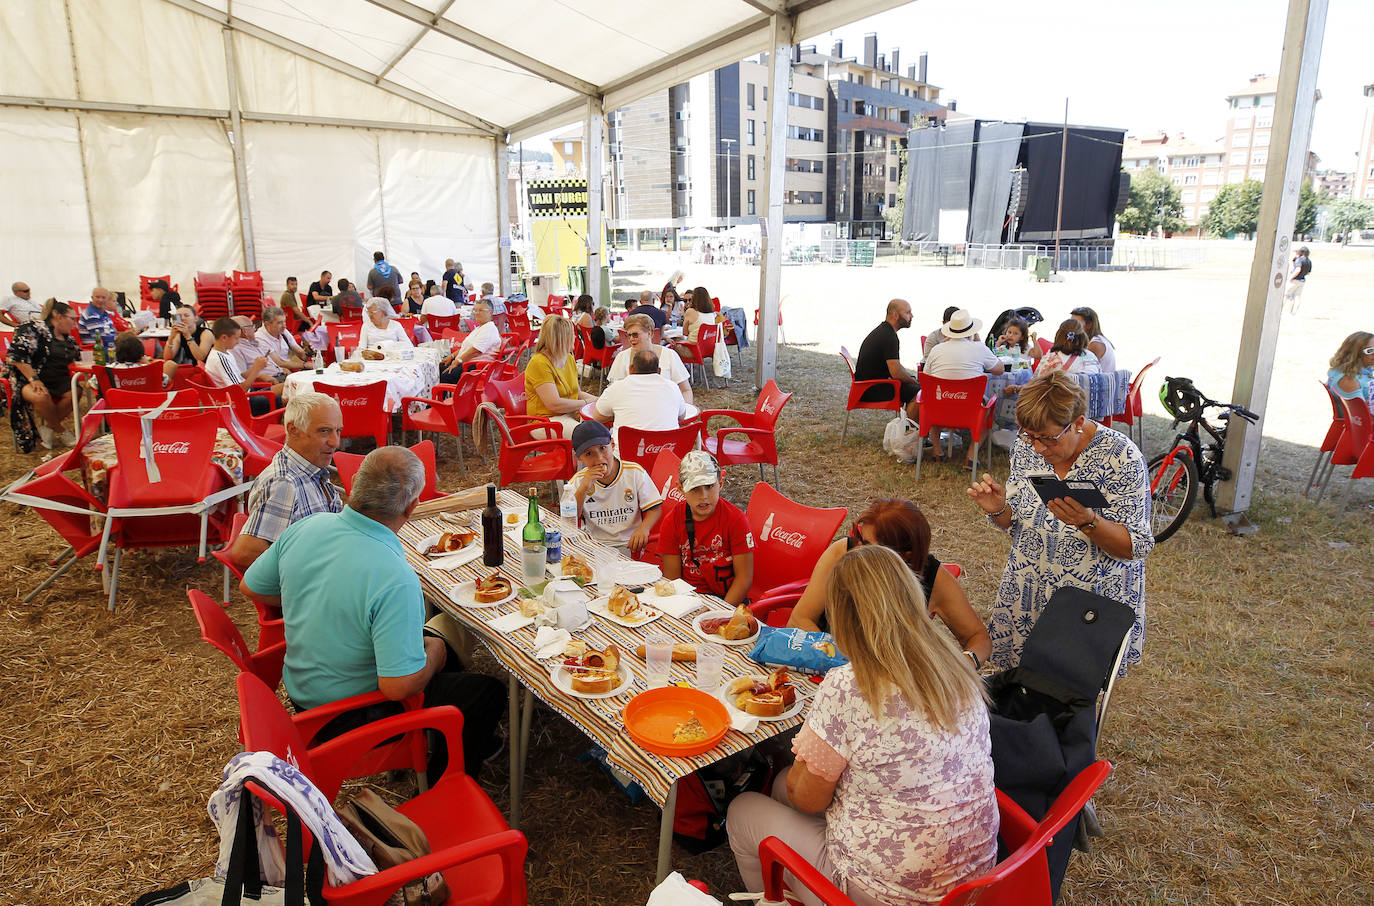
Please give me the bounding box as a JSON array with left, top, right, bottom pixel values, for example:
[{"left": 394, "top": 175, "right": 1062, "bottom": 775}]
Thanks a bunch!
[{"left": 754, "top": 15, "right": 796, "bottom": 388}]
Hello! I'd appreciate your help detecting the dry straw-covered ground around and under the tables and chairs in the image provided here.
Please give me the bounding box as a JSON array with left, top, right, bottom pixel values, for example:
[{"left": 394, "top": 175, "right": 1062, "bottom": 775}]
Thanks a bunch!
[{"left": 0, "top": 335, "right": 1374, "bottom": 906}]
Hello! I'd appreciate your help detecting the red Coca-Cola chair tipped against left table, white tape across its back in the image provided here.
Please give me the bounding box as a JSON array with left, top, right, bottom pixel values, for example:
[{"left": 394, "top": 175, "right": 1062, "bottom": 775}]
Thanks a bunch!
[{"left": 100, "top": 412, "right": 235, "bottom": 610}]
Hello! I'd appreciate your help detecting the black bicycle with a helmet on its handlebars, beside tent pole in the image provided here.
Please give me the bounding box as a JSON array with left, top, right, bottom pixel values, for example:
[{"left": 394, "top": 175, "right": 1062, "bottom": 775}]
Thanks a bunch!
[{"left": 1149, "top": 378, "right": 1260, "bottom": 542}]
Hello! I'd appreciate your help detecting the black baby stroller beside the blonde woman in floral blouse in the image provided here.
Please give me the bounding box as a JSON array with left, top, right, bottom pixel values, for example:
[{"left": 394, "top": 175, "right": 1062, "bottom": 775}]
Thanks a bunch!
[{"left": 988, "top": 586, "right": 1135, "bottom": 898}]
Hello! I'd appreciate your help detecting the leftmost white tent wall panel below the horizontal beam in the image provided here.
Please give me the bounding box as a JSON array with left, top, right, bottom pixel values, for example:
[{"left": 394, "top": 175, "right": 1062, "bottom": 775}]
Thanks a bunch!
[{"left": 0, "top": 109, "right": 95, "bottom": 300}]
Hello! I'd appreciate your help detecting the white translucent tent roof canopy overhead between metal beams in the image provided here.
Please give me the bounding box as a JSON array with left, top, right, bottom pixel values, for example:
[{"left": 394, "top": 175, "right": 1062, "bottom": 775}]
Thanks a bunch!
[{"left": 168, "top": 0, "right": 904, "bottom": 140}]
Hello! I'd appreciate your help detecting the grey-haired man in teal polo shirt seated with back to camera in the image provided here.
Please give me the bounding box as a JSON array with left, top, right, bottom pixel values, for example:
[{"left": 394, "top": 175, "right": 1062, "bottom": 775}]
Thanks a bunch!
[{"left": 242, "top": 447, "right": 506, "bottom": 782}]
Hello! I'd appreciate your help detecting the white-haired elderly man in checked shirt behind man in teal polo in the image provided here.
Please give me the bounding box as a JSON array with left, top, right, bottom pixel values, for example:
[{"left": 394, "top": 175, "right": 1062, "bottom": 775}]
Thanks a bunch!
[{"left": 229, "top": 392, "right": 344, "bottom": 569}]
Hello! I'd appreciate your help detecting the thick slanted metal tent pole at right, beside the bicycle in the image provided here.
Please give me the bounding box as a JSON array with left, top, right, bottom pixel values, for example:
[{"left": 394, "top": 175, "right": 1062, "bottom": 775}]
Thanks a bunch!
[{"left": 1217, "top": 0, "right": 1327, "bottom": 532}]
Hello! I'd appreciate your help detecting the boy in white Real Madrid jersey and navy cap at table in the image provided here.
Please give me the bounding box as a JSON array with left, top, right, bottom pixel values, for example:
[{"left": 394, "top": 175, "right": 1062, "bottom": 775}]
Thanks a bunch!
[{"left": 573, "top": 421, "right": 664, "bottom": 551}]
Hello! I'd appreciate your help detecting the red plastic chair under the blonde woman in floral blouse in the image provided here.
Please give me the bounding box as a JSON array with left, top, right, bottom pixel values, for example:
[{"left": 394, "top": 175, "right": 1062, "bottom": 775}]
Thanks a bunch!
[{"left": 758, "top": 762, "right": 1112, "bottom": 906}]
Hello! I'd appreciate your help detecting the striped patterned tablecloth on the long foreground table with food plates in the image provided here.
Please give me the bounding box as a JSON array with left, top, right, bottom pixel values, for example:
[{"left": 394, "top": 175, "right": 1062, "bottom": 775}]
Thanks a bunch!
[{"left": 400, "top": 491, "right": 816, "bottom": 806}]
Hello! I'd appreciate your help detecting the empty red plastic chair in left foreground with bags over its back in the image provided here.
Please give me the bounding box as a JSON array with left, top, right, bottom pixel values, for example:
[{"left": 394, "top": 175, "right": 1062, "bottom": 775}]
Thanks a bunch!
[{"left": 238, "top": 674, "right": 528, "bottom": 906}]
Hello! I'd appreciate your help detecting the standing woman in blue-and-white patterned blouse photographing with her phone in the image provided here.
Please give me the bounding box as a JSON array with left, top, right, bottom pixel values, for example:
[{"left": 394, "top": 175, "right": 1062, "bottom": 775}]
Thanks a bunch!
[{"left": 969, "top": 371, "right": 1154, "bottom": 670}]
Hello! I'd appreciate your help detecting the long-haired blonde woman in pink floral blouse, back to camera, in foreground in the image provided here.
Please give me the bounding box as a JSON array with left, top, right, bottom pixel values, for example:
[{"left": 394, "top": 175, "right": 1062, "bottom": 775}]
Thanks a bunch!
[{"left": 725, "top": 544, "right": 998, "bottom": 906}]
